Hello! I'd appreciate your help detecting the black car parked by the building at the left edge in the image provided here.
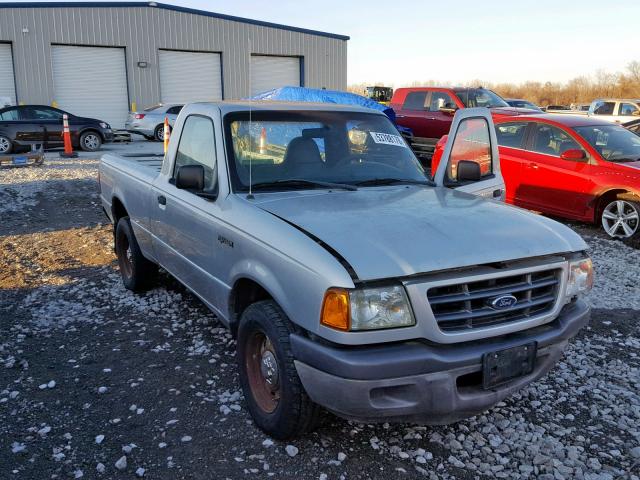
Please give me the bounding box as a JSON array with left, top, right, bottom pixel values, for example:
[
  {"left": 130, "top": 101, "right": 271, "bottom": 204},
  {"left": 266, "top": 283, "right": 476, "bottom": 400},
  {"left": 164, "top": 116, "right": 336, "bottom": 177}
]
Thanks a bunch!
[{"left": 0, "top": 105, "right": 113, "bottom": 154}]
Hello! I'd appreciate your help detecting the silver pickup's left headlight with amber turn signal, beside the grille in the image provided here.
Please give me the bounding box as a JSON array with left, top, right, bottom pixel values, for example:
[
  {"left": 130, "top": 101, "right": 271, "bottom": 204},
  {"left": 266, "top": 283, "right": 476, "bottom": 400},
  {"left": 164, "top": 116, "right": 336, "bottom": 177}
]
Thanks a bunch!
[{"left": 321, "top": 285, "right": 416, "bottom": 331}]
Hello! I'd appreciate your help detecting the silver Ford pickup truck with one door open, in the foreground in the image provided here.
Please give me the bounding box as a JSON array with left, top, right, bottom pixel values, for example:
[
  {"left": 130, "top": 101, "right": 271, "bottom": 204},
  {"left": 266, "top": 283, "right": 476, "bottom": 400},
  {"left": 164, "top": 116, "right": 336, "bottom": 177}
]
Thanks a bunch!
[{"left": 100, "top": 102, "right": 593, "bottom": 439}]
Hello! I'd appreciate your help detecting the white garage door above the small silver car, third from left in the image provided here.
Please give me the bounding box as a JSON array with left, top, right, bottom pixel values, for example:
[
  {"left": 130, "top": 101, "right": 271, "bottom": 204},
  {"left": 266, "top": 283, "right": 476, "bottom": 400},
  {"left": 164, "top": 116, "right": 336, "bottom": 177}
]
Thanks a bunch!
[{"left": 158, "top": 50, "right": 222, "bottom": 103}]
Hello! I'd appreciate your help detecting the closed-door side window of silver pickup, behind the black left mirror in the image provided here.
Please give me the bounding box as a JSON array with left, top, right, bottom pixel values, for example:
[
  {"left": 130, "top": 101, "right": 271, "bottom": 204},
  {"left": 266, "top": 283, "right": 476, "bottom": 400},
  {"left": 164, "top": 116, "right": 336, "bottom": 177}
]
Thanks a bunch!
[{"left": 173, "top": 115, "right": 216, "bottom": 190}]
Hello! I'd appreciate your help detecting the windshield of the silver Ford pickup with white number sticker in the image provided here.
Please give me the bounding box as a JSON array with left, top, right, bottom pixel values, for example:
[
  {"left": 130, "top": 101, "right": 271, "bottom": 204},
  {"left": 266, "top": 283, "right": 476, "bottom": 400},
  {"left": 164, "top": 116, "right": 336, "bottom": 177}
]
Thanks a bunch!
[{"left": 225, "top": 111, "right": 431, "bottom": 192}]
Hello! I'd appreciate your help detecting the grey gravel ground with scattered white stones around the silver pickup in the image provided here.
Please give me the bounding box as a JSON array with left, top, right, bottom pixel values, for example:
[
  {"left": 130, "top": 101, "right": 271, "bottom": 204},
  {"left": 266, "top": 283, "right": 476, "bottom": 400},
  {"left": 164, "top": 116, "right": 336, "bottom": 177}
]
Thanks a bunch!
[{"left": 0, "top": 155, "right": 640, "bottom": 480}]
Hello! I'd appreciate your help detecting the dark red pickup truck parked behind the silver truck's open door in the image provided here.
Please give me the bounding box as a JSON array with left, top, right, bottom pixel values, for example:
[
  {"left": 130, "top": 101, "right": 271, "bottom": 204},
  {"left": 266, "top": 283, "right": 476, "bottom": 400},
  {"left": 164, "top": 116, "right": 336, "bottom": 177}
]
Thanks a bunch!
[{"left": 389, "top": 87, "right": 540, "bottom": 167}]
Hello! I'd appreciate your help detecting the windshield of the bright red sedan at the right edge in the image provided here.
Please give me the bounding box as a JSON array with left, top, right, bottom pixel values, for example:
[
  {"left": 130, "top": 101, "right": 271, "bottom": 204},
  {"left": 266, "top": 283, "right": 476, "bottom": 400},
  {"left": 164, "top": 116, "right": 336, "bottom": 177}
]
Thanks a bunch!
[{"left": 574, "top": 125, "right": 640, "bottom": 162}]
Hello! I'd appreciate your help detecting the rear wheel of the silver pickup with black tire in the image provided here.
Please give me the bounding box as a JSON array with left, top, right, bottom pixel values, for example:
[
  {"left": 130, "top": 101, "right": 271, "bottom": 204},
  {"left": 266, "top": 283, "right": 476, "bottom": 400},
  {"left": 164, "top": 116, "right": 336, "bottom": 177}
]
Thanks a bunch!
[{"left": 115, "top": 217, "right": 158, "bottom": 292}]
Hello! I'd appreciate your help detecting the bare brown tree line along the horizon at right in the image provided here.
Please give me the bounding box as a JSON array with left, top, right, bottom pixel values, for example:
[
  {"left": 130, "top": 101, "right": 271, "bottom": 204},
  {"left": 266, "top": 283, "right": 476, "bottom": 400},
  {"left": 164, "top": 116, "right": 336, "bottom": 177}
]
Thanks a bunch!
[{"left": 348, "top": 61, "right": 640, "bottom": 106}]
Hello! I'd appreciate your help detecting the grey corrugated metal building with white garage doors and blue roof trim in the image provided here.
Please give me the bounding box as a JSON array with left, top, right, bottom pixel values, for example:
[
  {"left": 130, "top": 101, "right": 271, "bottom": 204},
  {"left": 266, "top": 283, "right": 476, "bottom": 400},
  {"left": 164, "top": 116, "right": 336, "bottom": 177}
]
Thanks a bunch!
[{"left": 0, "top": 2, "right": 349, "bottom": 128}]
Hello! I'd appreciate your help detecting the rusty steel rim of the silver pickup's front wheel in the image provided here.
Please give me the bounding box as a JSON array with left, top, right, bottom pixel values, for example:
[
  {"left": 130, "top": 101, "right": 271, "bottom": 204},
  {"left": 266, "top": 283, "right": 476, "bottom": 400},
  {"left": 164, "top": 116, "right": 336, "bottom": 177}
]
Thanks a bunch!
[{"left": 245, "top": 331, "right": 280, "bottom": 413}]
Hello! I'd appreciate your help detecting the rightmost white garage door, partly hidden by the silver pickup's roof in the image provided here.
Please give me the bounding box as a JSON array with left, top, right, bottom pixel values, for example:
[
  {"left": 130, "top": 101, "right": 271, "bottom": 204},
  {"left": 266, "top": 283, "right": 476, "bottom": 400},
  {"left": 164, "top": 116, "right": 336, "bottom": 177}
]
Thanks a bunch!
[{"left": 251, "top": 55, "right": 300, "bottom": 95}]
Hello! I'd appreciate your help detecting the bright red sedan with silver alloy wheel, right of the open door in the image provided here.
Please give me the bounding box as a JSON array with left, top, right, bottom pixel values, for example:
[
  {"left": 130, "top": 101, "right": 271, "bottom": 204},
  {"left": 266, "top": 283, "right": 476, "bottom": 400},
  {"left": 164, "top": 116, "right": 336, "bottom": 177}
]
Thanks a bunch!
[{"left": 433, "top": 114, "right": 640, "bottom": 244}]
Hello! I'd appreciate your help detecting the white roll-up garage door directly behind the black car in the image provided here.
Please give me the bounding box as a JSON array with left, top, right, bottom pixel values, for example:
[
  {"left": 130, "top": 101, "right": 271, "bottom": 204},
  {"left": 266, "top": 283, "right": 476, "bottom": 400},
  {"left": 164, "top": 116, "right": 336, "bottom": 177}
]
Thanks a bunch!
[{"left": 51, "top": 45, "right": 129, "bottom": 128}]
